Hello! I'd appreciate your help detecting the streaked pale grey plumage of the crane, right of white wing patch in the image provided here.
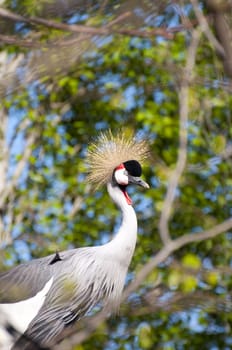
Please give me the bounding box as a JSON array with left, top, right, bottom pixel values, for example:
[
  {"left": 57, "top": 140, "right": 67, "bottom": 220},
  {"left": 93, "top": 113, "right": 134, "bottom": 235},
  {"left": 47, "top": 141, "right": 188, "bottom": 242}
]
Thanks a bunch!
[{"left": 12, "top": 249, "right": 118, "bottom": 350}]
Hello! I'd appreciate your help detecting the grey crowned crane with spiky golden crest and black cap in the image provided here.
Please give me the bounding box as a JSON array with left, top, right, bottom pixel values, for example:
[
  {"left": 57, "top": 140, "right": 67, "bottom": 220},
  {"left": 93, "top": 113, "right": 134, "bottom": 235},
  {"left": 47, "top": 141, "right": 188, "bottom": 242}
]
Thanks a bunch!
[{"left": 0, "top": 130, "right": 149, "bottom": 350}]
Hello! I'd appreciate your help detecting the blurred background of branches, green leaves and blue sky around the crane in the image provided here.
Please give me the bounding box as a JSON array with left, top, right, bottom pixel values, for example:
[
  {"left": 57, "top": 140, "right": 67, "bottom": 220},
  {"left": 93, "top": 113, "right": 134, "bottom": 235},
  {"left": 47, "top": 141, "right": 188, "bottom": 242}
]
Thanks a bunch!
[{"left": 0, "top": 0, "right": 232, "bottom": 350}]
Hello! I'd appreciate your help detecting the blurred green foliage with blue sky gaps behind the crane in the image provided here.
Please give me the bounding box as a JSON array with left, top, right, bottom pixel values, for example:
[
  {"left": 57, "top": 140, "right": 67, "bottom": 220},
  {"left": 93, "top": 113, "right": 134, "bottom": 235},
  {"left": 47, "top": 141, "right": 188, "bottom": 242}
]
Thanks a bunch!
[{"left": 0, "top": 0, "right": 232, "bottom": 350}]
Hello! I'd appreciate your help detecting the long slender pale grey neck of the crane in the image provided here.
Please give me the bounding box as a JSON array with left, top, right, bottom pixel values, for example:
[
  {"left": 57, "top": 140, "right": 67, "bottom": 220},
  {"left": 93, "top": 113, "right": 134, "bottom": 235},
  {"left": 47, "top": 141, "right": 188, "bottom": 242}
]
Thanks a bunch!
[{"left": 107, "top": 183, "right": 137, "bottom": 265}]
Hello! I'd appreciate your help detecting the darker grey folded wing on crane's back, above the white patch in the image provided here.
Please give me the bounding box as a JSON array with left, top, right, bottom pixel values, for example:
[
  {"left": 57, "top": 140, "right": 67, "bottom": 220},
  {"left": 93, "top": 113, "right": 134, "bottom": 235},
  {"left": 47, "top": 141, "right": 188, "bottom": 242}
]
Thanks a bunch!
[{"left": 0, "top": 250, "right": 76, "bottom": 303}]
